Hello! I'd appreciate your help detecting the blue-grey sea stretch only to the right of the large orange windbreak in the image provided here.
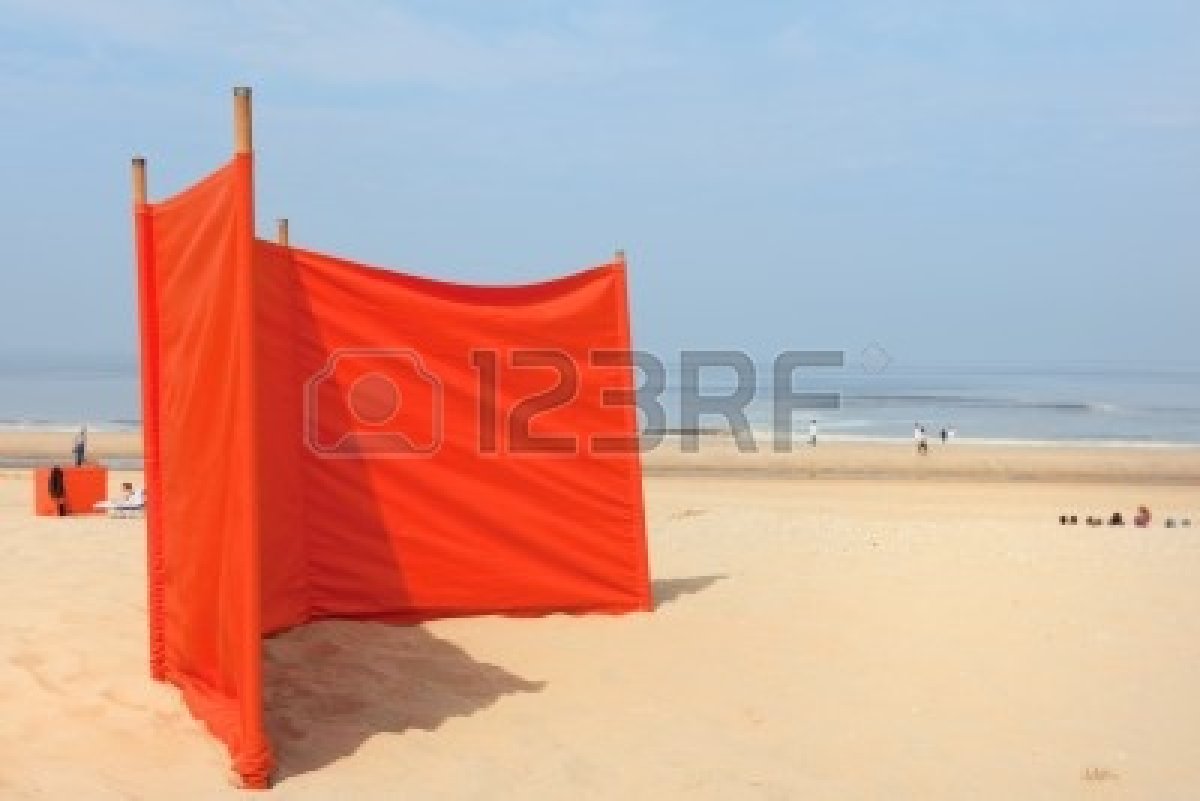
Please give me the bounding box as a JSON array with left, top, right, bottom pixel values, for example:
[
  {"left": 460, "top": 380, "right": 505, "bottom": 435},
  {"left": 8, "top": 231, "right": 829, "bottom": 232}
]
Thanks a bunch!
[{"left": 661, "top": 363, "right": 1200, "bottom": 446}]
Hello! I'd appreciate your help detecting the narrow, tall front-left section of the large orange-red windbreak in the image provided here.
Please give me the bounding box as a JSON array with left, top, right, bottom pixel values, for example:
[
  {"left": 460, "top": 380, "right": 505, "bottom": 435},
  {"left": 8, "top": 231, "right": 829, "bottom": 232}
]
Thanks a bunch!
[{"left": 137, "top": 155, "right": 271, "bottom": 787}]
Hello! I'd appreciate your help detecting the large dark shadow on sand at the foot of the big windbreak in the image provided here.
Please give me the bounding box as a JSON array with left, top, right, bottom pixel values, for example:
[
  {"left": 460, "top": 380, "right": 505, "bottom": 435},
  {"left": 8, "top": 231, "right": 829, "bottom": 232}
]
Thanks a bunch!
[{"left": 264, "top": 620, "right": 545, "bottom": 781}]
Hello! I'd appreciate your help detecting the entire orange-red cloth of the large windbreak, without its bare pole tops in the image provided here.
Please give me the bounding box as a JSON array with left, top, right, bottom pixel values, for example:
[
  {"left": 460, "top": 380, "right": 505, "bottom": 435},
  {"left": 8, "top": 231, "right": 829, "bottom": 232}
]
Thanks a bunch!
[{"left": 134, "top": 155, "right": 652, "bottom": 788}]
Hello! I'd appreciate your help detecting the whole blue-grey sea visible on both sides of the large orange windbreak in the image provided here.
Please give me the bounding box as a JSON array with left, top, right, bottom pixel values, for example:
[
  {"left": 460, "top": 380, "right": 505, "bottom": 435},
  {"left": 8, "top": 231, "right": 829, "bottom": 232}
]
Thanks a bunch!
[{"left": 0, "top": 357, "right": 1200, "bottom": 447}]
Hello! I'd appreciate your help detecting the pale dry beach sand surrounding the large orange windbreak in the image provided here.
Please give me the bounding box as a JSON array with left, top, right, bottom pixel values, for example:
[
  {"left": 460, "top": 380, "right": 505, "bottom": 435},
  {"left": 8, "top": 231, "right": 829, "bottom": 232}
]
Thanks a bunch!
[{"left": 0, "top": 448, "right": 1200, "bottom": 801}]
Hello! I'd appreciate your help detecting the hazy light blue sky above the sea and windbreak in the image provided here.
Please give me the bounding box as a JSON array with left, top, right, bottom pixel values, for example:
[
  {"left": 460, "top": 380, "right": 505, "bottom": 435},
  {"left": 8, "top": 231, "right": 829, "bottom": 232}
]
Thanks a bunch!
[{"left": 0, "top": 0, "right": 1200, "bottom": 366}]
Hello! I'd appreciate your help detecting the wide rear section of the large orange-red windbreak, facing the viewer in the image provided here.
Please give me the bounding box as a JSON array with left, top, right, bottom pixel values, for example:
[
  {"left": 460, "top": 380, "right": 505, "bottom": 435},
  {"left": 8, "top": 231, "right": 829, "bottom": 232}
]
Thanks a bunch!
[{"left": 256, "top": 242, "right": 650, "bottom": 631}]
